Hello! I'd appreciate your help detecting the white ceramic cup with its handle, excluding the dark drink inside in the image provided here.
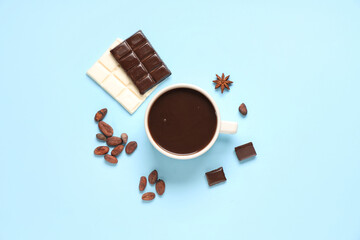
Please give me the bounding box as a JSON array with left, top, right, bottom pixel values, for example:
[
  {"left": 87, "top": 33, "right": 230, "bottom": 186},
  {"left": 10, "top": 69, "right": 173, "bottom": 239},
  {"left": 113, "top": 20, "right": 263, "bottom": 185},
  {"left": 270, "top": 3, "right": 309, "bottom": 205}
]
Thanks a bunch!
[{"left": 145, "top": 83, "right": 238, "bottom": 160}]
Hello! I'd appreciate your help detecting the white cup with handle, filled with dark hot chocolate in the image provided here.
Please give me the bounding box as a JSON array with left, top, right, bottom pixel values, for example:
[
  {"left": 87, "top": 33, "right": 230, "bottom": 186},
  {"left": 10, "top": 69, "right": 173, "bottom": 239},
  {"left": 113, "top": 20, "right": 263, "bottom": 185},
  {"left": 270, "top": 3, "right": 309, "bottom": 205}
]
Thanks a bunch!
[{"left": 145, "top": 84, "right": 237, "bottom": 160}]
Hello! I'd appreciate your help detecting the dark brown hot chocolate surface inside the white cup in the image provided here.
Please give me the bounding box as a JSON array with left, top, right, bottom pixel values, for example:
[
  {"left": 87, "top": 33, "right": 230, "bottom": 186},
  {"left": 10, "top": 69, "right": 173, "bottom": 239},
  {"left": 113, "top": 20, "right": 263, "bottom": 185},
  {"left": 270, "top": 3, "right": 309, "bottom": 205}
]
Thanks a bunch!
[{"left": 148, "top": 88, "right": 217, "bottom": 154}]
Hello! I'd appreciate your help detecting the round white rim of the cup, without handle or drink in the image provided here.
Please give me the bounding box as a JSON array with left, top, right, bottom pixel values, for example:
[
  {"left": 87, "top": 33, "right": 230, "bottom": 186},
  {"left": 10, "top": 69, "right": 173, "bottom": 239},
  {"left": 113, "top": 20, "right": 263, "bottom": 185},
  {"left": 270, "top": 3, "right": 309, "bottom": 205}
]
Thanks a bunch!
[{"left": 144, "top": 83, "right": 221, "bottom": 160}]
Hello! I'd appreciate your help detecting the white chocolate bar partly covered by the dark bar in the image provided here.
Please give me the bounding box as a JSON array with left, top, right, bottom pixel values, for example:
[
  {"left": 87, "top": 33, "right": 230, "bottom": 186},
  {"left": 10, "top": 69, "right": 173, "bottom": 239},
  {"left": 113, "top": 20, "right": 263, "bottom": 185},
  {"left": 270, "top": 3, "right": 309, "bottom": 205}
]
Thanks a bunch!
[{"left": 86, "top": 39, "right": 156, "bottom": 114}]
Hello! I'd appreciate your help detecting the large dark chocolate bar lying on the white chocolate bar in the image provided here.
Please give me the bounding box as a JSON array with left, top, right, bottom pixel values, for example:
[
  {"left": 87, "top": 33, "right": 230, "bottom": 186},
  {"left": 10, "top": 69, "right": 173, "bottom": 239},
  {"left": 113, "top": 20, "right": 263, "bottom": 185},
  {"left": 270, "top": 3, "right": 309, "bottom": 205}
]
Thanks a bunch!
[{"left": 110, "top": 30, "right": 171, "bottom": 94}]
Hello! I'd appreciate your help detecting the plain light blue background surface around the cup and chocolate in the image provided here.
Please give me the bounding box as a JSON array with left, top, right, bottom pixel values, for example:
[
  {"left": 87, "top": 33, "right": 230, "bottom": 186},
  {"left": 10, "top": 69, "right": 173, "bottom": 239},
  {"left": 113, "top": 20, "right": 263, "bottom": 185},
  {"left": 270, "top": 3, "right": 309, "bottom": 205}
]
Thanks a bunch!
[{"left": 0, "top": 0, "right": 360, "bottom": 240}]
